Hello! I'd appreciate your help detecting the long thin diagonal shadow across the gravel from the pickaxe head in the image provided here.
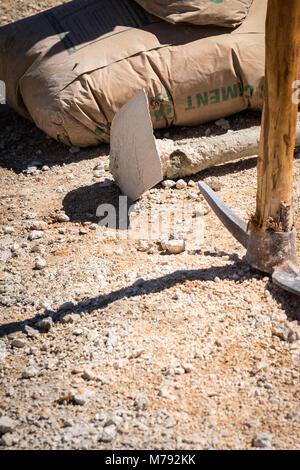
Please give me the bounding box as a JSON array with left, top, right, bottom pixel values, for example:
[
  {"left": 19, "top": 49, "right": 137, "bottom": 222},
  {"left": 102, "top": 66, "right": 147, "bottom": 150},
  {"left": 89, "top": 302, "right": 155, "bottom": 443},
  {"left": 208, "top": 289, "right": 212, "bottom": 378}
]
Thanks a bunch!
[{"left": 0, "top": 258, "right": 300, "bottom": 338}]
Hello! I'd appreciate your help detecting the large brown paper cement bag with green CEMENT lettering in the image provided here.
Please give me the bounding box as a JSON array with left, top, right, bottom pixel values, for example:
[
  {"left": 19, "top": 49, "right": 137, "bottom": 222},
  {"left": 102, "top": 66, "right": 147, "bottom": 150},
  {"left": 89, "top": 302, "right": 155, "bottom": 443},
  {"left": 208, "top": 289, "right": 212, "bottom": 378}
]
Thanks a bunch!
[{"left": 0, "top": 0, "right": 266, "bottom": 147}]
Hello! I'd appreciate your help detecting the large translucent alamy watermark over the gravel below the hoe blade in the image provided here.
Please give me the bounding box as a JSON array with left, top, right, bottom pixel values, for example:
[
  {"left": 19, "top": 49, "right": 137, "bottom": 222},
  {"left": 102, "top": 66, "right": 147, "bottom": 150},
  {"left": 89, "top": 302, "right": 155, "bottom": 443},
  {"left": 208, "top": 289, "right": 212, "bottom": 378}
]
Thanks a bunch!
[{"left": 96, "top": 196, "right": 204, "bottom": 250}]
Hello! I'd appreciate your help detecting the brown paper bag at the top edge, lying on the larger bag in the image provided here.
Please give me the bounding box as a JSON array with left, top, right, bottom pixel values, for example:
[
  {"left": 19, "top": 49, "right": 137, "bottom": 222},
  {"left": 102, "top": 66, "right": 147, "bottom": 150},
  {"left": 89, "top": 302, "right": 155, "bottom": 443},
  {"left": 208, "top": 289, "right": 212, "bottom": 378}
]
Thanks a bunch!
[{"left": 136, "top": 0, "right": 253, "bottom": 27}]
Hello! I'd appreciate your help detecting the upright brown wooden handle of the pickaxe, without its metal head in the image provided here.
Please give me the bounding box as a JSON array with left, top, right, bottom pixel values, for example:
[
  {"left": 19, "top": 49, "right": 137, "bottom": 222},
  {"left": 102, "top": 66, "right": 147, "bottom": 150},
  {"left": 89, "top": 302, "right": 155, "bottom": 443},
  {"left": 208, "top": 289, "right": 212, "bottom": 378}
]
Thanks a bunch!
[{"left": 250, "top": 0, "right": 300, "bottom": 232}]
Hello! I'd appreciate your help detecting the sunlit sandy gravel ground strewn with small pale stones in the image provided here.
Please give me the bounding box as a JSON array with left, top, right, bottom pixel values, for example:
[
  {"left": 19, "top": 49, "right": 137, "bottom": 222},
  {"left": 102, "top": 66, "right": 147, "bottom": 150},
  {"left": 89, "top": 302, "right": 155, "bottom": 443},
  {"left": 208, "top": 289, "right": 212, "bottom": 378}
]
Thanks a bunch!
[{"left": 0, "top": 0, "right": 300, "bottom": 450}]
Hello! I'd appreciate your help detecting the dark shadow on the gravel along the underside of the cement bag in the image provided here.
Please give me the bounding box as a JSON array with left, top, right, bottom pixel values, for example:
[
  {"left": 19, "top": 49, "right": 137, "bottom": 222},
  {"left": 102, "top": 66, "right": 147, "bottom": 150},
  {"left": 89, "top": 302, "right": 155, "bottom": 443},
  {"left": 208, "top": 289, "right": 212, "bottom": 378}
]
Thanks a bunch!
[{"left": 0, "top": 105, "right": 260, "bottom": 173}]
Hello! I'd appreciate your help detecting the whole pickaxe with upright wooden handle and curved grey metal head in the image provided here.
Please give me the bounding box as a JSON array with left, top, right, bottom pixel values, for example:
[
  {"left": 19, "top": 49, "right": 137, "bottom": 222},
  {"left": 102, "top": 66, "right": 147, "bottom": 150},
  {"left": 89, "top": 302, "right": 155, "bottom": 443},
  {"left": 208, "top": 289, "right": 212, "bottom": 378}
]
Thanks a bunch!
[{"left": 199, "top": 0, "right": 300, "bottom": 295}]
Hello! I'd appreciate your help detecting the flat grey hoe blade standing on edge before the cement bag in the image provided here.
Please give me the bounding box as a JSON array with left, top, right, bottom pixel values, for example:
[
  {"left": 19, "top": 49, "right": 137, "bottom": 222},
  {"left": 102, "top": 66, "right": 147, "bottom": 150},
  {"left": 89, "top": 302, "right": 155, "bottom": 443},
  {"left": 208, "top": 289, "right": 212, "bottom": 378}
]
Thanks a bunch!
[{"left": 110, "top": 89, "right": 163, "bottom": 201}]
